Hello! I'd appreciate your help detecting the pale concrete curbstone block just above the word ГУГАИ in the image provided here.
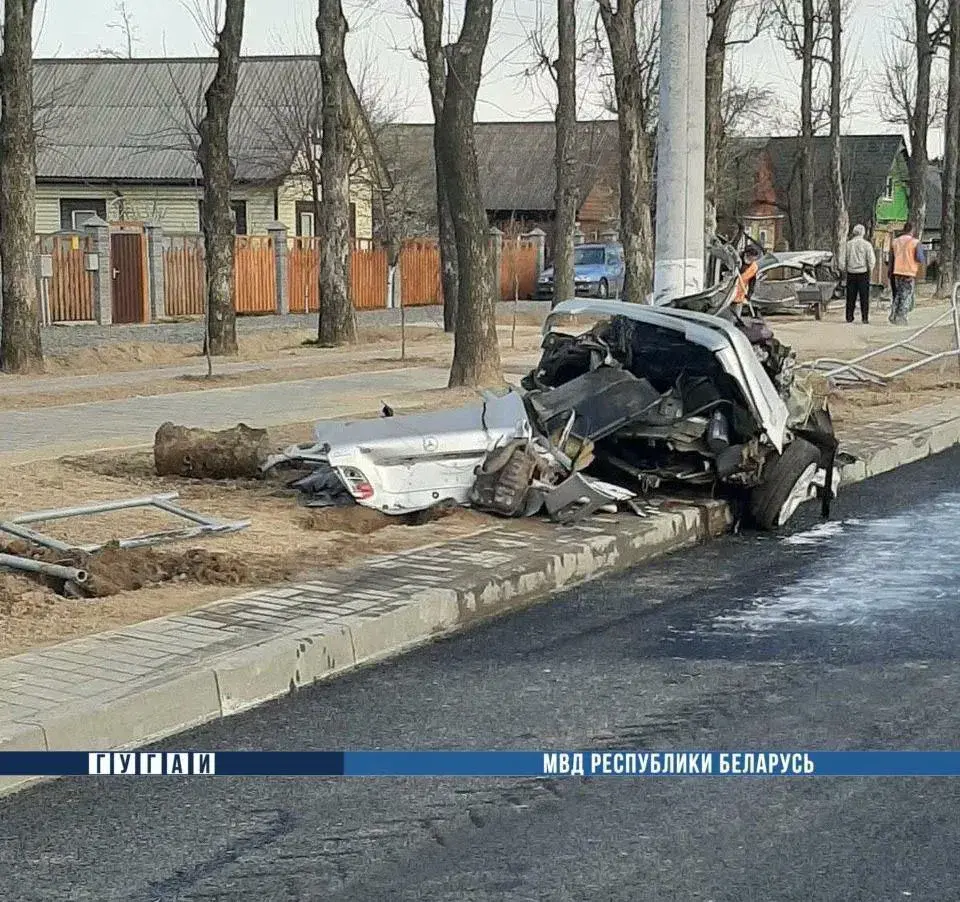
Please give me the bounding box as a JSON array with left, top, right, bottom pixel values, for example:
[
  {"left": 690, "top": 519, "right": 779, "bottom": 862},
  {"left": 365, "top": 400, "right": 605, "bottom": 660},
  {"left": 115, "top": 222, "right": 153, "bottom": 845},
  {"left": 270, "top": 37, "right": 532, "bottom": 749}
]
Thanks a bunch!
[{"left": 39, "top": 668, "right": 220, "bottom": 752}]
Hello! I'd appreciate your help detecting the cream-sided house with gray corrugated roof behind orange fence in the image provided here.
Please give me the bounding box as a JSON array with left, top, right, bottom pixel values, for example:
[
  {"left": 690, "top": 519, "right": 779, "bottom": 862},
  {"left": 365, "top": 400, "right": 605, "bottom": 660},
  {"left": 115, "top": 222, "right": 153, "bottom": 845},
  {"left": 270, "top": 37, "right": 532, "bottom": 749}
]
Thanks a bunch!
[{"left": 34, "top": 56, "right": 372, "bottom": 238}]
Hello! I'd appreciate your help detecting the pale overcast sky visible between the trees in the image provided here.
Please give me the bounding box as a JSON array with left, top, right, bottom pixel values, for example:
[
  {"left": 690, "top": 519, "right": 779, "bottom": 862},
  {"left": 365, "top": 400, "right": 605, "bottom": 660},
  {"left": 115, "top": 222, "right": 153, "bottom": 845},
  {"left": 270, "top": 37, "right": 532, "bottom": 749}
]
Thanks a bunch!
[{"left": 36, "top": 0, "right": 940, "bottom": 154}]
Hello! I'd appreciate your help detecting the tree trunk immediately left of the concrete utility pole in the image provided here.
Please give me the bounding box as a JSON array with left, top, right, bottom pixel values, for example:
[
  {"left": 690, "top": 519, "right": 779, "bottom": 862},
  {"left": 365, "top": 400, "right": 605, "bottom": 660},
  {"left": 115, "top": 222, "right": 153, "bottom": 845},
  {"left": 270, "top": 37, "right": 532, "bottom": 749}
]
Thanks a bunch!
[{"left": 600, "top": 0, "right": 653, "bottom": 301}]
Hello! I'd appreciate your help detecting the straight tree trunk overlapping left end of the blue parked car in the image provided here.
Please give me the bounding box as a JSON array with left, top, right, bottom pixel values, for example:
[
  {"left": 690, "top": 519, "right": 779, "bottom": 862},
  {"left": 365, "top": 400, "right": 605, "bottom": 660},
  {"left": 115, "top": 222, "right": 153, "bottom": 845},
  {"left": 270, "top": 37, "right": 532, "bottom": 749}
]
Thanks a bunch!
[{"left": 553, "top": 0, "right": 579, "bottom": 305}]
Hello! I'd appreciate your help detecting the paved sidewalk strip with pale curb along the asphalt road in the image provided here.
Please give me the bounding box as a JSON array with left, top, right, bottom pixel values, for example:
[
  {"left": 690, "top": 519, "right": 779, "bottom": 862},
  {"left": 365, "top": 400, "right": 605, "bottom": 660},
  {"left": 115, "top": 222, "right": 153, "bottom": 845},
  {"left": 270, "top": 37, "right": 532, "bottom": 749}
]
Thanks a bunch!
[{"left": 0, "top": 401, "right": 960, "bottom": 792}]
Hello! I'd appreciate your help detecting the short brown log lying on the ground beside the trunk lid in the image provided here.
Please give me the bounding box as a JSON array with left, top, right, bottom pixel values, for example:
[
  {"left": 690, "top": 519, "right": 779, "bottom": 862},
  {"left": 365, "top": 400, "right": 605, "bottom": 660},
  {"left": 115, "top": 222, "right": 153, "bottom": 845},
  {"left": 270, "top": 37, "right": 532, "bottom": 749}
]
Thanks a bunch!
[{"left": 153, "top": 423, "right": 269, "bottom": 479}]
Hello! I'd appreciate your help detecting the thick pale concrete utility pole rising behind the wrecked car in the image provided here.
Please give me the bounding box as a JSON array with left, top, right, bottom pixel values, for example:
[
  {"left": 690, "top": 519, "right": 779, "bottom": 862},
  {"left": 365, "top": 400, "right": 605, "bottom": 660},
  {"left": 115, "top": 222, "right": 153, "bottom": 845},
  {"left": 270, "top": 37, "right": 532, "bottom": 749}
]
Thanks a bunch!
[{"left": 653, "top": 0, "right": 707, "bottom": 304}]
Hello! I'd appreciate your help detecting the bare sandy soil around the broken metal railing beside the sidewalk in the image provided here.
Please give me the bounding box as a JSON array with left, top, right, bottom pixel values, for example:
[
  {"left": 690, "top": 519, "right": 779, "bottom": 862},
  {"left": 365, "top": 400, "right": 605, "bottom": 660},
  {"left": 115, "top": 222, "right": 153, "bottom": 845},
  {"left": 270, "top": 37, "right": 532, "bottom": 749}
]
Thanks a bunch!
[{"left": 0, "top": 389, "right": 510, "bottom": 656}]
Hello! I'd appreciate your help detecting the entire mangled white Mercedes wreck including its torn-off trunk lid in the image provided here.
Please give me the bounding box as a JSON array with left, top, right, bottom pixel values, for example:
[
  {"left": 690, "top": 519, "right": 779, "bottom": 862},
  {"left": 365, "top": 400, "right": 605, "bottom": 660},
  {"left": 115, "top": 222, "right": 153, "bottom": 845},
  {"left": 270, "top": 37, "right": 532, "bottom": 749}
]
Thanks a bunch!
[{"left": 265, "top": 244, "right": 837, "bottom": 529}]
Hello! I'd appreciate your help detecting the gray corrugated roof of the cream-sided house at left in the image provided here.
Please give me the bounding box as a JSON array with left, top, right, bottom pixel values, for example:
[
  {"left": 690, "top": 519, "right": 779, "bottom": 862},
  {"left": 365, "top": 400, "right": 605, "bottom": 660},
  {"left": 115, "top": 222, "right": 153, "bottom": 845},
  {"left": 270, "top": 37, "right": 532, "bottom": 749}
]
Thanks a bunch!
[{"left": 34, "top": 56, "right": 320, "bottom": 182}]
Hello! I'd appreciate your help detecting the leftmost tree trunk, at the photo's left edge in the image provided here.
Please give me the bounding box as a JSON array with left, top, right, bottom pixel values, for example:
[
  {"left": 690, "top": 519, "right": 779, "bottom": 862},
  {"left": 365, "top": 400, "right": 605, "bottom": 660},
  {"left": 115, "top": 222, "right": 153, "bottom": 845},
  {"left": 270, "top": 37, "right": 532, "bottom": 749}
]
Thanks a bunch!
[{"left": 0, "top": 0, "right": 43, "bottom": 373}]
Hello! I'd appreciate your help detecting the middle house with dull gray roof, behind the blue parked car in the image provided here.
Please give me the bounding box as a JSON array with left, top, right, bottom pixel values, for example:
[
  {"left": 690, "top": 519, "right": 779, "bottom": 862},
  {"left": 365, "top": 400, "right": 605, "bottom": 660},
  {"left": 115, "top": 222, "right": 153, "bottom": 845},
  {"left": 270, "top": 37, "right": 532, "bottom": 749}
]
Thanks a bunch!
[{"left": 378, "top": 120, "right": 620, "bottom": 254}]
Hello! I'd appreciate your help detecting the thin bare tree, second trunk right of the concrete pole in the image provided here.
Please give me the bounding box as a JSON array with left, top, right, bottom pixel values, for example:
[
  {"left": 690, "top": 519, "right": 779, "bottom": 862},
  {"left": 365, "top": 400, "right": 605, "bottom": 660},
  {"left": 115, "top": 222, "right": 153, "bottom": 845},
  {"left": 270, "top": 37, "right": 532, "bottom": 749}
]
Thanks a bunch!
[{"left": 774, "top": 0, "right": 829, "bottom": 247}]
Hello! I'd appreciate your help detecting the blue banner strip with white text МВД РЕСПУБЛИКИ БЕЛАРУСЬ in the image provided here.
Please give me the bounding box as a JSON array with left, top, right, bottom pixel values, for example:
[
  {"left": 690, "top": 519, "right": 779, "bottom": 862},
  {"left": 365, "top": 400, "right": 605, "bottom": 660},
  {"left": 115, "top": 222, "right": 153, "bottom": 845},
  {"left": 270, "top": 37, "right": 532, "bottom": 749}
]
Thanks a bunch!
[{"left": 0, "top": 750, "right": 960, "bottom": 777}]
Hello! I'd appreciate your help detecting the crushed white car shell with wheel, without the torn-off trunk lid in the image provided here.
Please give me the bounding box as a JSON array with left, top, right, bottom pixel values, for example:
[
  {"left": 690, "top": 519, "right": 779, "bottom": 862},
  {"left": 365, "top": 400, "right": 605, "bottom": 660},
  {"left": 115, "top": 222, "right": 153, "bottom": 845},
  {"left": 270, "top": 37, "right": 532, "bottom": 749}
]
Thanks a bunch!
[{"left": 523, "top": 301, "right": 837, "bottom": 529}]
